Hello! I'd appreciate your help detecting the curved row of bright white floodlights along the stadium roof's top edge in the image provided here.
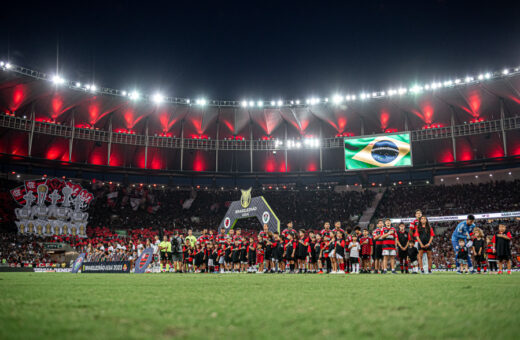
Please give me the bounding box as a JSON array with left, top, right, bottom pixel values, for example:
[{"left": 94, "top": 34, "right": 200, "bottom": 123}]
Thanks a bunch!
[{"left": 0, "top": 61, "right": 520, "bottom": 109}]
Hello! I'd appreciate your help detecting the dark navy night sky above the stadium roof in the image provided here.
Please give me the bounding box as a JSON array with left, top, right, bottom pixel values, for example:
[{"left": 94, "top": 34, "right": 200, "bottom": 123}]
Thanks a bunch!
[{"left": 0, "top": 0, "right": 520, "bottom": 100}]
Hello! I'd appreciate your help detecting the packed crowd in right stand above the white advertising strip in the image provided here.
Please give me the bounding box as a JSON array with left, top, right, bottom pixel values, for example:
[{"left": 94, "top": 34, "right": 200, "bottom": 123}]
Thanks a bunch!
[{"left": 376, "top": 180, "right": 520, "bottom": 218}]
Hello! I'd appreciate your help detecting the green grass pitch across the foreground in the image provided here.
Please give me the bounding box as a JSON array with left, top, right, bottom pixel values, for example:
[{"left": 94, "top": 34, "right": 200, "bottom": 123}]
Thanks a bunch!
[{"left": 0, "top": 273, "right": 520, "bottom": 339}]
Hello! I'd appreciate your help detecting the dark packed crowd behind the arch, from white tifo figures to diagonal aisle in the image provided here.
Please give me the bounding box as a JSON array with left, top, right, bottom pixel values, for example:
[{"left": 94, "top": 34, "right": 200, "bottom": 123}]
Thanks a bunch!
[{"left": 89, "top": 185, "right": 375, "bottom": 231}]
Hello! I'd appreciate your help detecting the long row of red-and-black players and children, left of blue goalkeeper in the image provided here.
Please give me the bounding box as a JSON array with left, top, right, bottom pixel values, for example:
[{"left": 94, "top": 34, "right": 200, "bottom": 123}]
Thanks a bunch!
[{"left": 156, "top": 217, "right": 434, "bottom": 274}]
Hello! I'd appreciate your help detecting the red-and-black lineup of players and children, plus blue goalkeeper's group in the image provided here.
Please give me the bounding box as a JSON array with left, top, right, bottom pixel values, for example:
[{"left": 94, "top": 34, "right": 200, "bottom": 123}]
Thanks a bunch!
[{"left": 153, "top": 210, "right": 512, "bottom": 274}]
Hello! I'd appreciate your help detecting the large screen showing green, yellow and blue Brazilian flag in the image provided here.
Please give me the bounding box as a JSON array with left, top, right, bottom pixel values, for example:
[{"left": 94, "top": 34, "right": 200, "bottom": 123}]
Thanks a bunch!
[{"left": 345, "top": 133, "right": 412, "bottom": 170}]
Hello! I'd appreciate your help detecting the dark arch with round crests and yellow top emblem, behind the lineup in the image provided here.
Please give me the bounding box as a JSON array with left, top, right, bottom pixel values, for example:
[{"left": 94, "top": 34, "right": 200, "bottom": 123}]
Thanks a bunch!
[{"left": 219, "top": 188, "right": 280, "bottom": 232}]
